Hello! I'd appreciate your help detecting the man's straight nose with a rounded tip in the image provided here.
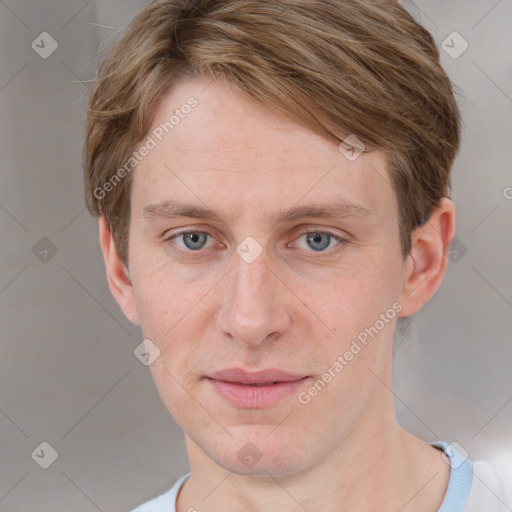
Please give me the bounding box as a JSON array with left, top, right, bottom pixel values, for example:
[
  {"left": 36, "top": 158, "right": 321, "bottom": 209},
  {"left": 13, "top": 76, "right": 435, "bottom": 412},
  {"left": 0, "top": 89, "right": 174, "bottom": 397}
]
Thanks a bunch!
[{"left": 218, "top": 248, "right": 291, "bottom": 346}]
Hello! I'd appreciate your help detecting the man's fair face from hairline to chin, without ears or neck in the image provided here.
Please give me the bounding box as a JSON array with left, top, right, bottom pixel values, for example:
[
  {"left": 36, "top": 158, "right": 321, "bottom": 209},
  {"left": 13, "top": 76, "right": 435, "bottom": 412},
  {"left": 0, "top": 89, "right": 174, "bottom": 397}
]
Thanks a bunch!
[{"left": 119, "top": 79, "right": 403, "bottom": 475}]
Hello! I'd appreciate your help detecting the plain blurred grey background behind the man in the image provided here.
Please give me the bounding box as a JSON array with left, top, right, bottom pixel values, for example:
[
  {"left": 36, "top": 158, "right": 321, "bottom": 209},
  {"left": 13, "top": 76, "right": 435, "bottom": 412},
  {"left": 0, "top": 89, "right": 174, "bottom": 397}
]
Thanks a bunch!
[{"left": 0, "top": 0, "right": 512, "bottom": 512}]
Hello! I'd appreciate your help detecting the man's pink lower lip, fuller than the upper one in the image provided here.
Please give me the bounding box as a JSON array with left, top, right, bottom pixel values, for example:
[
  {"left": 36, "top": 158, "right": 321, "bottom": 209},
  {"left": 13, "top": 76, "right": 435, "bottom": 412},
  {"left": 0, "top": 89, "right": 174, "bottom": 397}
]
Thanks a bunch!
[{"left": 208, "top": 377, "right": 309, "bottom": 409}]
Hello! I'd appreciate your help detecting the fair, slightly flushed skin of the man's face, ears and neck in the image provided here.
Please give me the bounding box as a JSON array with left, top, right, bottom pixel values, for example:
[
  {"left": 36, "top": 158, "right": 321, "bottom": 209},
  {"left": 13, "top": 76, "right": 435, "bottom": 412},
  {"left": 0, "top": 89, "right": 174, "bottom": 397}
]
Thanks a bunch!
[{"left": 100, "top": 78, "right": 455, "bottom": 512}]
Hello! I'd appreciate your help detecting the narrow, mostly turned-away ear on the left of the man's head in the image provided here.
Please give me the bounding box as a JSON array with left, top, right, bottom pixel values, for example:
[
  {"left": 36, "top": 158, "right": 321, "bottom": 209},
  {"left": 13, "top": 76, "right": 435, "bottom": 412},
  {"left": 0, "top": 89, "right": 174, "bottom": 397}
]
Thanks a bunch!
[{"left": 99, "top": 217, "right": 140, "bottom": 325}]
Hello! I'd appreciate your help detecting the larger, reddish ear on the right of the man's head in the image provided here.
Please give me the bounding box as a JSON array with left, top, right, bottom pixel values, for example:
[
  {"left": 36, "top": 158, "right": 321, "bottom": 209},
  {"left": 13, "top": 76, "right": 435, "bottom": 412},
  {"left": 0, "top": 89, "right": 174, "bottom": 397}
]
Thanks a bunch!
[{"left": 398, "top": 197, "right": 455, "bottom": 317}]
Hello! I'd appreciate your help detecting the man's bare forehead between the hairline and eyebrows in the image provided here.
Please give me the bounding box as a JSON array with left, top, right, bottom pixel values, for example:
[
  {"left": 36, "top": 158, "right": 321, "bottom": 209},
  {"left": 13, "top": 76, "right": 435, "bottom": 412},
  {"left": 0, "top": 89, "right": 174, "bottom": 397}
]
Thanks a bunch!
[{"left": 132, "top": 79, "right": 395, "bottom": 224}]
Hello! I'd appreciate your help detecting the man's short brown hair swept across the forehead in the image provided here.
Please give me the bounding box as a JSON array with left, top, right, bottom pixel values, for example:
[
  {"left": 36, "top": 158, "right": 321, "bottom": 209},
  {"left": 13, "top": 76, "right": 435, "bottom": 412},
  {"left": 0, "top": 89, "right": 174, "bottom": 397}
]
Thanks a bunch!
[{"left": 84, "top": 0, "right": 460, "bottom": 265}]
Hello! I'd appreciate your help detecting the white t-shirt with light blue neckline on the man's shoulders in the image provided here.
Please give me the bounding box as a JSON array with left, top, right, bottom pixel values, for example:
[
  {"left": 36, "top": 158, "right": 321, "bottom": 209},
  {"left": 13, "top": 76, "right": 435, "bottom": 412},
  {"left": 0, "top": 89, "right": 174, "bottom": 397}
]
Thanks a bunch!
[{"left": 132, "top": 441, "right": 512, "bottom": 512}]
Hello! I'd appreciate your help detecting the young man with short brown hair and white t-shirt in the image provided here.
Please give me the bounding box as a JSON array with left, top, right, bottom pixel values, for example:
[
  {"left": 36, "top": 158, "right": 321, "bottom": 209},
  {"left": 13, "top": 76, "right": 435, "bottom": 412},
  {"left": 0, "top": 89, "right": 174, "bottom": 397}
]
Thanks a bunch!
[{"left": 85, "top": 0, "right": 505, "bottom": 512}]
